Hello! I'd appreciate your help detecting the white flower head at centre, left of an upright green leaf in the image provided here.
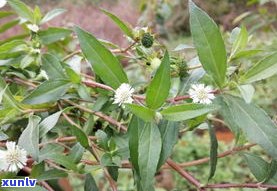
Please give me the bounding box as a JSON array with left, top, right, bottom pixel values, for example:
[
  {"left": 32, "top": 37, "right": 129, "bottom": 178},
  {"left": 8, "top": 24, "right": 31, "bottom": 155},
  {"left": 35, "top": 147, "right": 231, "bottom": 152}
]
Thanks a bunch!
[{"left": 113, "top": 83, "right": 135, "bottom": 106}]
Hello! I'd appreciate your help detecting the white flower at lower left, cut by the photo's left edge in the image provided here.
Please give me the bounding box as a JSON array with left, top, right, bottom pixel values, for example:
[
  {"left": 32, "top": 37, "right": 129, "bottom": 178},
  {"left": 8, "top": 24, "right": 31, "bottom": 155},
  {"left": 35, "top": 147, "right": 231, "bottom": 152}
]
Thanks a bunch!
[{"left": 0, "top": 142, "right": 27, "bottom": 172}]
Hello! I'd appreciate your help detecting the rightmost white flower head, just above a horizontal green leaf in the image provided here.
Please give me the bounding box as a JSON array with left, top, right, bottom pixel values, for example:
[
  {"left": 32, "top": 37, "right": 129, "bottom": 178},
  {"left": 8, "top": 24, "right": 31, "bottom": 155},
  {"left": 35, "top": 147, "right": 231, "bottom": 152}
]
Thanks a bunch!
[{"left": 189, "top": 84, "right": 215, "bottom": 104}]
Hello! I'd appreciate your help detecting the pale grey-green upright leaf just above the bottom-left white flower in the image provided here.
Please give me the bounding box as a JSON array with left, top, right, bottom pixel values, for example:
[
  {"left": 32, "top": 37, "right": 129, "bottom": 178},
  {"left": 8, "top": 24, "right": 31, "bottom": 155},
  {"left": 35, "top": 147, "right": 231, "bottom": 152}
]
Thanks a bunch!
[{"left": 18, "top": 116, "right": 40, "bottom": 161}]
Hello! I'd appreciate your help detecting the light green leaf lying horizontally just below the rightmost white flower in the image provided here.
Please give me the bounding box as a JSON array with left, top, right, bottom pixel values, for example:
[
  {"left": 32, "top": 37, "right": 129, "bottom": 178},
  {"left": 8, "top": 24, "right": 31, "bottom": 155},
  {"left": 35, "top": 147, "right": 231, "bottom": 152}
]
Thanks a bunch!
[{"left": 161, "top": 103, "right": 217, "bottom": 121}]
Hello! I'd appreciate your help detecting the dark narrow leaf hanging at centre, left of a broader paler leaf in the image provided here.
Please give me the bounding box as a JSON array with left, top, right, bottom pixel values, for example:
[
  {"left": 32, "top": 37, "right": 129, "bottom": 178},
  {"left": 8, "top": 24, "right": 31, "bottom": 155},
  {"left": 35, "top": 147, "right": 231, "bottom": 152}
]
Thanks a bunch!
[{"left": 128, "top": 115, "right": 145, "bottom": 174}]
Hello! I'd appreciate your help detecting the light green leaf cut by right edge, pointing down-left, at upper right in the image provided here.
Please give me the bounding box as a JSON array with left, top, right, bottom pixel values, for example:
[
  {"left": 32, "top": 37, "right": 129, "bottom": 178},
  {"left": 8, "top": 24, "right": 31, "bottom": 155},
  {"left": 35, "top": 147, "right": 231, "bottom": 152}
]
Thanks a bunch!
[{"left": 241, "top": 52, "right": 277, "bottom": 83}]
